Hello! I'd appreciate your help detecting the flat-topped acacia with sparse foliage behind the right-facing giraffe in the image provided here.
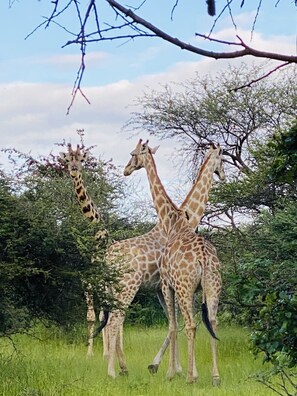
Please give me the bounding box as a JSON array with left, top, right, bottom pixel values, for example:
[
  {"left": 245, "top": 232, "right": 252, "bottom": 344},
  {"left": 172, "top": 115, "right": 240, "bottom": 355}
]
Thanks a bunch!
[{"left": 124, "top": 65, "right": 297, "bottom": 226}]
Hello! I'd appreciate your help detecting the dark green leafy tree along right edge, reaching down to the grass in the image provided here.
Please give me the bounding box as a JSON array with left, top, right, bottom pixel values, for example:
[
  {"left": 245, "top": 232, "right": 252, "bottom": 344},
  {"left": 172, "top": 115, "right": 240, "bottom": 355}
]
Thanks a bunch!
[{"left": 208, "top": 121, "right": 297, "bottom": 395}]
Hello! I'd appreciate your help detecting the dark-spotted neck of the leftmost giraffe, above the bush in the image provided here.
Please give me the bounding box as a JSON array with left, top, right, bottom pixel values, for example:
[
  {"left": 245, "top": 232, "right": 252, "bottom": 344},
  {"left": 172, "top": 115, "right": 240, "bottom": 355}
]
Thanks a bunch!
[{"left": 70, "top": 171, "right": 100, "bottom": 222}]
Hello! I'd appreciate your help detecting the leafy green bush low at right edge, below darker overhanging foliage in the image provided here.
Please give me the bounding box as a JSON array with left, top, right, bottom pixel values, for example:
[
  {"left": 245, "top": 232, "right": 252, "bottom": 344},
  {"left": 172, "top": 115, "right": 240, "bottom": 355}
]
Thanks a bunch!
[{"left": 214, "top": 202, "right": 297, "bottom": 365}]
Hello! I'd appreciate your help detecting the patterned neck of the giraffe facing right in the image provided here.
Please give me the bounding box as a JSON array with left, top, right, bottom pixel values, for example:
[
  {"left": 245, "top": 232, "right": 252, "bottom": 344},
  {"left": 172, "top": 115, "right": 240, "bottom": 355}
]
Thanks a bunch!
[{"left": 181, "top": 150, "right": 215, "bottom": 229}]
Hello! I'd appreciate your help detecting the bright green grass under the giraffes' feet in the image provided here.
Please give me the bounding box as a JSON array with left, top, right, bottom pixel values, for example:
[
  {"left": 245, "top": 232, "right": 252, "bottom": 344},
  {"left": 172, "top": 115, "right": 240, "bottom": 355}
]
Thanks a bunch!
[{"left": 0, "top": 327, "right": 275, "bottom": 396}]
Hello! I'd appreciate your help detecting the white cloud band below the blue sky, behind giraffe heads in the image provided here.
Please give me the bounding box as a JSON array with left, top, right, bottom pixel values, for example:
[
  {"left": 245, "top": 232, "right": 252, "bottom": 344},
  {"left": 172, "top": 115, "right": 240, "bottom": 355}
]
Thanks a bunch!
[{"left": 0, "top": 29, "right": 293, "bottom": 209}]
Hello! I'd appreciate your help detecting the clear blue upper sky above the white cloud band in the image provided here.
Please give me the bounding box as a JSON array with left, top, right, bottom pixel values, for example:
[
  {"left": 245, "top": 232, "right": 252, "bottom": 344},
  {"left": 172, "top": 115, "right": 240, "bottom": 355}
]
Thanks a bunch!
[{"left": 0, "top": 0, "right": 297, "bottom": 85}]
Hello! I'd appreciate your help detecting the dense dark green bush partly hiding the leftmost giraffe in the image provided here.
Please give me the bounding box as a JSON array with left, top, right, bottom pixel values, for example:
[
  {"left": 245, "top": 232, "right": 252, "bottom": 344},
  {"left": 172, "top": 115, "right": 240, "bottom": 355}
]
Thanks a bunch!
[{"left": 0, "top": 141, "right": 132, "bottom": 335}]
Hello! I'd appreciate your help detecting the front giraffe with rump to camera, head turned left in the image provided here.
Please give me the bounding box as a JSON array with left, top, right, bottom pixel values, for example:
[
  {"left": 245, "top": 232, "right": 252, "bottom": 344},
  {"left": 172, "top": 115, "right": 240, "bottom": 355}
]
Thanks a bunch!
[{"left": 124, "top": 140, "right": 225, "bottom": 385}]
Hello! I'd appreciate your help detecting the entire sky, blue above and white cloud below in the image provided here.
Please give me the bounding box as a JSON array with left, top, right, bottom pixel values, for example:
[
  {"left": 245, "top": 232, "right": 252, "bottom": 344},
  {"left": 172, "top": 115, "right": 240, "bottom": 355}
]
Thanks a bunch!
[{"left": 0, "top": 0, "right": 297, "bottom": 209}]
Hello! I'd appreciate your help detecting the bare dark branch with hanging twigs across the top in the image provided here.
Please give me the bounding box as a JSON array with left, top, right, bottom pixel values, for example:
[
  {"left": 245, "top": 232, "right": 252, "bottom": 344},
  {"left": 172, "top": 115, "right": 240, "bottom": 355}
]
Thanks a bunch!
[{"left": 21, "top": 0, "right": 297, "bottom": 111}]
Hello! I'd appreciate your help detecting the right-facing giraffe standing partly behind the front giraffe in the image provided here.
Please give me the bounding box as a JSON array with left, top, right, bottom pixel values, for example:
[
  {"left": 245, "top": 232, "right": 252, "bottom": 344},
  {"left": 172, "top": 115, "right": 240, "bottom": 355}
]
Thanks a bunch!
[{"left": 103, "top": 138, "right": 224, "bottom": 377}]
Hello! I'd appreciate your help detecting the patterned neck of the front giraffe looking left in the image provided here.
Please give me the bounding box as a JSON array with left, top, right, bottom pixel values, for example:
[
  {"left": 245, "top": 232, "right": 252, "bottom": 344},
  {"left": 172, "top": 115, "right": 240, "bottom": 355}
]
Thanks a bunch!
[{"left": 145, "top": 152, "right": 179, "bottom": 234}]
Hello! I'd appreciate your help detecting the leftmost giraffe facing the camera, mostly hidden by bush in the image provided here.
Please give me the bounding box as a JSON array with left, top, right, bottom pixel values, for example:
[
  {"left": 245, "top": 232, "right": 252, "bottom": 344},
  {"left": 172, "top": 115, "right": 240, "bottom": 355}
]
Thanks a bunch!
[{"left": 59, "top": 143, "right": 108, "bottom": 357}]
